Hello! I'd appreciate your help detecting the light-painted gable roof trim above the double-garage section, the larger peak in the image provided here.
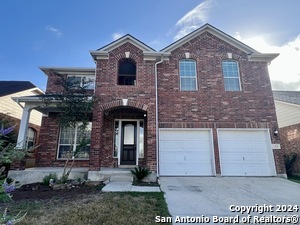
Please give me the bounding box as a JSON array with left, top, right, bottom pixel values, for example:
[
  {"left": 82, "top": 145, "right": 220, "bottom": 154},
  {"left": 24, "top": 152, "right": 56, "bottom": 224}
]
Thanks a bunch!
[{"left": 160, "top": 23, "right": 279, "bottom": 62}]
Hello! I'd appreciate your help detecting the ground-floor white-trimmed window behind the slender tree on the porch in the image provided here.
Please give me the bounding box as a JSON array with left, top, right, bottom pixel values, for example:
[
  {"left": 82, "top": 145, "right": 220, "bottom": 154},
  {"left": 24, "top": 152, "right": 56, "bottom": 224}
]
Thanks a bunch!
[{"left": 57, "top": 122, "right": 92, "bottom": 159}]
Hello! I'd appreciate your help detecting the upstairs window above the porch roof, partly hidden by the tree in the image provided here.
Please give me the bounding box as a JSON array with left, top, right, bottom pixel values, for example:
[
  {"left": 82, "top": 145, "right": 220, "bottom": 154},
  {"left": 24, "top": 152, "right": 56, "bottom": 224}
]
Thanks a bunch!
[{"left": 67, "top": 75, "right": 95, "bottom": 90}]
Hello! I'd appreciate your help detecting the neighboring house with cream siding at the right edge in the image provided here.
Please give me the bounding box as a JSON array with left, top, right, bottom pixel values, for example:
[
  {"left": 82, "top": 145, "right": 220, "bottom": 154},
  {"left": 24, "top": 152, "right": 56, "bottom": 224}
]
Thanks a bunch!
[{"left": 273, "top": 91, "right": 300, "bottom": 174}]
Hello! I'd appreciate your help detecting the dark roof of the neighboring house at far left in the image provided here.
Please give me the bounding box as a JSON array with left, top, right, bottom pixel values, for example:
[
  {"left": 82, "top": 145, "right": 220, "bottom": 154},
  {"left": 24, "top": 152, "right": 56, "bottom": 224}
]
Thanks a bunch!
[{"left": 0, "top": 81, "right": 37, "bottom": 97}]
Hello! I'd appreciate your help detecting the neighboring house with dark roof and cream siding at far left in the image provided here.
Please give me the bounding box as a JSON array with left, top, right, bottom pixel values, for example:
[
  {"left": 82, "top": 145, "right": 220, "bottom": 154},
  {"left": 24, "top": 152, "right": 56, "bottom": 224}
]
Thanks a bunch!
[{"left": 0, "top": 81, "right": 44, "bottom": 167}]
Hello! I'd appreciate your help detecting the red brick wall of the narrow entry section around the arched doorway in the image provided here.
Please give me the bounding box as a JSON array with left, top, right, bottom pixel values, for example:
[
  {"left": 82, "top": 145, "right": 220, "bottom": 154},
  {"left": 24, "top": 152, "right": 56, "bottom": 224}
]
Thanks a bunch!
[{"left": 90, "top": 43, "right": 156, "bottom": 170}]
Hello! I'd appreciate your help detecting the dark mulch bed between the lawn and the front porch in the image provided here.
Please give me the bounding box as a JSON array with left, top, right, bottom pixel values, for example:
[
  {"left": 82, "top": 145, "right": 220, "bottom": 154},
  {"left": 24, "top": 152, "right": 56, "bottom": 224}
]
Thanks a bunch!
[{"left": 11, "top": 183, "right": 99, "bottom": 201}]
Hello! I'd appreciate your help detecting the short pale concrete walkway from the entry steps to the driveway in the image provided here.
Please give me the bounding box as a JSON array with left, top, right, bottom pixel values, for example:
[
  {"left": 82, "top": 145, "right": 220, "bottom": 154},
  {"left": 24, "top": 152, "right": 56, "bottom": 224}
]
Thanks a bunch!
[{"left": 102, "top": 181, "right": 161, "bottom": 192}]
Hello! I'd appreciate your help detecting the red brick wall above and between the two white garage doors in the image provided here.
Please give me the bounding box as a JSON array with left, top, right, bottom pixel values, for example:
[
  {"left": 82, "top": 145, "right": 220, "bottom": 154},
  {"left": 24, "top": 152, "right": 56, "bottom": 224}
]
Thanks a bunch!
[{"left": 158, "top": 33, "right": 285, "bottom": 173}]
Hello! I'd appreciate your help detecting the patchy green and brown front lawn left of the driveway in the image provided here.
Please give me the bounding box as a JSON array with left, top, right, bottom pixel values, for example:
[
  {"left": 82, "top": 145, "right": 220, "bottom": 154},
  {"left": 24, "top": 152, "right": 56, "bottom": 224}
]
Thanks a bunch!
[{"left": 0, "top": 192, "right": 170, "bottom": 225}]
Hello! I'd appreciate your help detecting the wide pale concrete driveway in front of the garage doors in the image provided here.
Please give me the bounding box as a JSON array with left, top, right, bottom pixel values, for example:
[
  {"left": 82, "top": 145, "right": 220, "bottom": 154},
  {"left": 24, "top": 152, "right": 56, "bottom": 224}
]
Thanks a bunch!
[{"left": 156, "top": 177, "right": 300, "bottom": 224}]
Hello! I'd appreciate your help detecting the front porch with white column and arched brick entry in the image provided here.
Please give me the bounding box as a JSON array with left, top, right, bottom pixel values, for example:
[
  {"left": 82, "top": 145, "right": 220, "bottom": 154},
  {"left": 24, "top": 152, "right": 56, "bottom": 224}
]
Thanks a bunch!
[{"left": 10, "top": 97, "right": 157, "bottom": 177}]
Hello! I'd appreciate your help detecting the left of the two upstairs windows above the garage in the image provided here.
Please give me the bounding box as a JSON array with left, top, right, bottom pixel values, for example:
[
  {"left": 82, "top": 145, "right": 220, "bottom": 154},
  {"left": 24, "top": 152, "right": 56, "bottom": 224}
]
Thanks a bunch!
[{"left": 179, "top": 59, "right": 197, "bottom": 91}]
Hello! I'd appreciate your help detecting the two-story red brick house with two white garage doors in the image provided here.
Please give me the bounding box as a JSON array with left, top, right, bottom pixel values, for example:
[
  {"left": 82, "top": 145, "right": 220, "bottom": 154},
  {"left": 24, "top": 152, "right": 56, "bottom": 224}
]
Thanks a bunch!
[{"left": 12, "top": 24, "right": 286, "bottom": 177}]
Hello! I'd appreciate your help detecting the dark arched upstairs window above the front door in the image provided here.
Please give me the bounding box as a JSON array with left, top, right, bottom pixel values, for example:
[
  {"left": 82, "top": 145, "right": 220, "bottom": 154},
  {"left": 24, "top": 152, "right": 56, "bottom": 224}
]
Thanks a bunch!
[{"left": 118, "top": 59, "right": 136, "bottom": 85}]
